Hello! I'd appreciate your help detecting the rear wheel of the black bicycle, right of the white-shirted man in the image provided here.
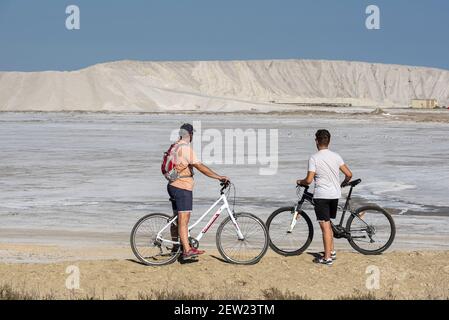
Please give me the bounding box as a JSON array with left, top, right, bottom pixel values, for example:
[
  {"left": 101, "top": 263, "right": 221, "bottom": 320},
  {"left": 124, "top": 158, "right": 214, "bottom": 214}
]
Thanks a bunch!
[{"left": 346, "top": 206, "right": 396, "bottom": 255}]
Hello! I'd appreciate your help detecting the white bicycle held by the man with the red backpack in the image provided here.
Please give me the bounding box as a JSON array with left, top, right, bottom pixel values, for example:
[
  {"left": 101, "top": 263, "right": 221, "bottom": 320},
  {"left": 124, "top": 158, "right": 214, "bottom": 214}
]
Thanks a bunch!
[{"left": 131, "top": 182, "right": 269, "bottom": 266}]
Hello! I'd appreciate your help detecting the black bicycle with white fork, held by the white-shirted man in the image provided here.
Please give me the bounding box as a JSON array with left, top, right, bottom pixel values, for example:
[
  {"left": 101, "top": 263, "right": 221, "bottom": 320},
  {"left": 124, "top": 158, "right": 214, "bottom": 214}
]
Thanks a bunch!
[{"left": 266, "top": 179, "right": 396, "bottom": 256}]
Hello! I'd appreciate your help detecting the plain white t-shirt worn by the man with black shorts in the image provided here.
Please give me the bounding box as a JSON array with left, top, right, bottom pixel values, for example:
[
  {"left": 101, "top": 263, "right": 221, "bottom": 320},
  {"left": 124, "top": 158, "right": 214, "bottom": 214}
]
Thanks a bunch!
[{"left": 309, "top": 149, "right": 345, "bottom": 199}]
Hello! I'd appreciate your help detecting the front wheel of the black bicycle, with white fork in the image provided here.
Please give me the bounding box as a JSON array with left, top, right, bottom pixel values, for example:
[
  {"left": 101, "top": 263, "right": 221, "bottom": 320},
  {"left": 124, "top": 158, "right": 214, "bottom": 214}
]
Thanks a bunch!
[{"left": 267, "top": 207, "right": 313, "bottom": 256}]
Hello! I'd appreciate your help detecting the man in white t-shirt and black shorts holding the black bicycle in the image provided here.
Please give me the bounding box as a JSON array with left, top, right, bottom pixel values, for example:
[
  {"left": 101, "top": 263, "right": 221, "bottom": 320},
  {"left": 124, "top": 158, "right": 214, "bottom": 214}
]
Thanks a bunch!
[{"left": 297, "top": 130, "right": 352, "bottom": 265}]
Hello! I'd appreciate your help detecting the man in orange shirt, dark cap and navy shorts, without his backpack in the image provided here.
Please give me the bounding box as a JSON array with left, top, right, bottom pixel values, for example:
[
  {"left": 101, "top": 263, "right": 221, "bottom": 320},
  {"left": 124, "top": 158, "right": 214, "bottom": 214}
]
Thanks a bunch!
[{"left": 167, "top": 123, "right": 229, "bottom": 260}]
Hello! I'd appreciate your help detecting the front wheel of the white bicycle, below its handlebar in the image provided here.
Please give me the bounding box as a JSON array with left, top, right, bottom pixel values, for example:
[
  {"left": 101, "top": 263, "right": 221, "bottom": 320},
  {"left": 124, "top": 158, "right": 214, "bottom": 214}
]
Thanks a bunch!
[{"left": 216, "top": 213, "right": 268, "bottom": 264}]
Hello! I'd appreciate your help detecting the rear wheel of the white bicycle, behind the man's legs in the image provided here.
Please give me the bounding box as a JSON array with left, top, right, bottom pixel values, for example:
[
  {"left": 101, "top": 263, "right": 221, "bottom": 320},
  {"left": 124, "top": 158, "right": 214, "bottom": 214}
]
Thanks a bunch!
[{"left": 130, "top": 213, "right": 181, "bottom": 266}]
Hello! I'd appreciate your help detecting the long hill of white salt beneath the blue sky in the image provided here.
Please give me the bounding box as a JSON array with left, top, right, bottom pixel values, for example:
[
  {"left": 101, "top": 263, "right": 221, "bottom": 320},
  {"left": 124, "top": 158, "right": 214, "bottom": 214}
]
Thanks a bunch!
[{"left": 0, "top": 60, "right": 449, "bottom": 112}]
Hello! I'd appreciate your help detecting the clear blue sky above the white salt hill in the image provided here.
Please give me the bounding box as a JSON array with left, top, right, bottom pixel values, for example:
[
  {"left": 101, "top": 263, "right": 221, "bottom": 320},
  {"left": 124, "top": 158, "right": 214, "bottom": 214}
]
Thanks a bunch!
[{"left": 0, "top": 0, "right": 449, "bottom": 71}]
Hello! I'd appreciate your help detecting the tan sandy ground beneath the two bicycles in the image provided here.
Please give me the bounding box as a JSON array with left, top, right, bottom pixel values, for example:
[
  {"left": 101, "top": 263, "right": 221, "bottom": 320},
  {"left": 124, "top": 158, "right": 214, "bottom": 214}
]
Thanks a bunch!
[{"left": 0, "top": 245, "right": 449, "bottom": 299}]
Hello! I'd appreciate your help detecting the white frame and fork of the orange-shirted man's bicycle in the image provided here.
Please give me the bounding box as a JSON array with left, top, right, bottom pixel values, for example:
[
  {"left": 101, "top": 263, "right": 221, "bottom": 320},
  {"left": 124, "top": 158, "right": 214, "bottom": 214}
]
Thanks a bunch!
[{"left": 156, "top": 193, "right": 245, "bottom": 245}]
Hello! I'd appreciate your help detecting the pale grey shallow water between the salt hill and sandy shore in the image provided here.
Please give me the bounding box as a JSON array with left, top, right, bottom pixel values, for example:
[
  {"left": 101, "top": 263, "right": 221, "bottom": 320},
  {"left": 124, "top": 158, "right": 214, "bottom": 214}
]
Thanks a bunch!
[{"left": 0, "top": 113, "right": 449, "bottom": 250}]
